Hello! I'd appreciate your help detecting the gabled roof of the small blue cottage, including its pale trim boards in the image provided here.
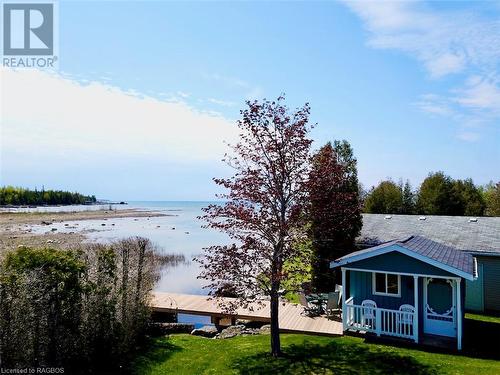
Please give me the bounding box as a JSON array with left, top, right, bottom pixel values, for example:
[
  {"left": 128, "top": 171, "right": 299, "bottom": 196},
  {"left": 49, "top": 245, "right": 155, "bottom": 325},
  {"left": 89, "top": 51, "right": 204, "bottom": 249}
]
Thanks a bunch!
[{"left": 330, "top": 236, "right": 474, "bottom": 280}]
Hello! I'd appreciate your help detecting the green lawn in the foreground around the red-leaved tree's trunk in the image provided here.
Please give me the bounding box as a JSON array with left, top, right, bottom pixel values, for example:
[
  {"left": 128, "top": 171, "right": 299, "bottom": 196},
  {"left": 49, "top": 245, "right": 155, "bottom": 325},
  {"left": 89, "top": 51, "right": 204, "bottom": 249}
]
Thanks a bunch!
[{"left": 133, "top": 334, "right": 500, "bottom": 375}]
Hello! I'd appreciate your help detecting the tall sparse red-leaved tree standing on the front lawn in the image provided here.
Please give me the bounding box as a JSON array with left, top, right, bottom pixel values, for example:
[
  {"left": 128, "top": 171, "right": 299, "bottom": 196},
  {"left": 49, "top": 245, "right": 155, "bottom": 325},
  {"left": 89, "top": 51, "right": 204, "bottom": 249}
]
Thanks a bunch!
[{"left": 198, "top": 96, "right": 311, "bottom": 356}]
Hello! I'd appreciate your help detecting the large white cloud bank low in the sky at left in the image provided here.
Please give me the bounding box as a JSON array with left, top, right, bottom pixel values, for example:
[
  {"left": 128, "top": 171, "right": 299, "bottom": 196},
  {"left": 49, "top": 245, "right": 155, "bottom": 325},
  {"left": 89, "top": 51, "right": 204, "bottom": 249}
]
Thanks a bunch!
[{"left": 0, "top": 69, "right": 237, "bottom": 164}]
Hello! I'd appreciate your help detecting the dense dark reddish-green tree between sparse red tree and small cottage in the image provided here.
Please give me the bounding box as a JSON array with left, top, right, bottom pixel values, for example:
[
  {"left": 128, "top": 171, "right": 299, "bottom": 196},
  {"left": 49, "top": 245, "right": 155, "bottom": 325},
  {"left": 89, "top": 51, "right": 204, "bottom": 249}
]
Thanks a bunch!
[{"left": 309, "top": 140, "right": 362, "bottom": 292}]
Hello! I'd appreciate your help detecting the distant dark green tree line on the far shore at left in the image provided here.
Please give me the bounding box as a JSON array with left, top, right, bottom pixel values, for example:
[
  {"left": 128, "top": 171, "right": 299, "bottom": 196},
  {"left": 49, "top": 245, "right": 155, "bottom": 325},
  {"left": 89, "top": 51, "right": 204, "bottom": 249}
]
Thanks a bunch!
[{"left": 0, "top": 186, "right": 97, "bottom": 206}]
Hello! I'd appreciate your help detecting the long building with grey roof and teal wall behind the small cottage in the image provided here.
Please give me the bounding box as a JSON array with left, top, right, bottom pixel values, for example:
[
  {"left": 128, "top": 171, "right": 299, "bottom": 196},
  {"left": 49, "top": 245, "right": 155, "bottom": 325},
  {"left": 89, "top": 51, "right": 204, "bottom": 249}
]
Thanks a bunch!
[{"left": 357, "top": 214, "right": 500, "bottom": 314}]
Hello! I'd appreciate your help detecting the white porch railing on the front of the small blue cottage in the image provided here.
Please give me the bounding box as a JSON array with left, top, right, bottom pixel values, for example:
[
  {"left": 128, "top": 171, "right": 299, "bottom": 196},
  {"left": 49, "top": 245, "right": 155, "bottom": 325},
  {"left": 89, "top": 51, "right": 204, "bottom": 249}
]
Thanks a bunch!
[{"left": 342, "top": 297, "right": 418, "bottom": 341}]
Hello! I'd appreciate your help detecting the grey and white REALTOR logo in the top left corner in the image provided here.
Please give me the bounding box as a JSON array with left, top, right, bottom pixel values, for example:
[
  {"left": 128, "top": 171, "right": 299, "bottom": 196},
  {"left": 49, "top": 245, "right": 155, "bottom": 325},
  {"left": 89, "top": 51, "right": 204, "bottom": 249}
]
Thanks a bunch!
[{"left": 2, "top": 0, "right": 57, "bottom": 68}]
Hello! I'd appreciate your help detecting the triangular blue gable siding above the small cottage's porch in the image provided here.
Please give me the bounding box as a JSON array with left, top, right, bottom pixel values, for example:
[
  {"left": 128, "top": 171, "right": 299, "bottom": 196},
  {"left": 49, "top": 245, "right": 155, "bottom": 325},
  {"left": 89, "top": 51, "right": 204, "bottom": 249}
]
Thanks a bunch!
[{"left": 346, "top": 245, "right": 456, "bottom": 277}]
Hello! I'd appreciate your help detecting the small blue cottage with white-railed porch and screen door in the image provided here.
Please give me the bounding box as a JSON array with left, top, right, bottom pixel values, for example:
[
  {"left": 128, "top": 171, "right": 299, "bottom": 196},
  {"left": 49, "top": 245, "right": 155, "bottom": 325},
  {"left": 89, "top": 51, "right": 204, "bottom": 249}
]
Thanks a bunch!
[{"left": 331, "top": 236, "right": 478, "bottom": 350}]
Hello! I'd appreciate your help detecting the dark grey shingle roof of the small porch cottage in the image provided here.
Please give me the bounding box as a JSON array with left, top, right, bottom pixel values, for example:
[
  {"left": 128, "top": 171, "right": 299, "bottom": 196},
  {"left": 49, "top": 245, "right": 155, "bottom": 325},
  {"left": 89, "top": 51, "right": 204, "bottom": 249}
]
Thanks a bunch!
[{"left": 337, "top": 236, "right": 474, "bottom": 275}]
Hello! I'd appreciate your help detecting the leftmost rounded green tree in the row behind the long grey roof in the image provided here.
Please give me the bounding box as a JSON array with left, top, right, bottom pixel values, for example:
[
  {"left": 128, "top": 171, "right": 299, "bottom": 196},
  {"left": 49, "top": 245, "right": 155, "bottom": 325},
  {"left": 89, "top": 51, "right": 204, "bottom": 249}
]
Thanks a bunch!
[{"left": 365, "top": 180, "right": 403, "bottom": 214}]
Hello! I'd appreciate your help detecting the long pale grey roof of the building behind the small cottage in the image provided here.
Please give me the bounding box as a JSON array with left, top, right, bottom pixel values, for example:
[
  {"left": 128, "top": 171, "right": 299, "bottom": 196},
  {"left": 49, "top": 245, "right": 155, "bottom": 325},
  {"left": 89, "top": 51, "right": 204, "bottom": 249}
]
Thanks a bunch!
[{"left": 357, "top": 214, "right": 500, "bottom": 253}]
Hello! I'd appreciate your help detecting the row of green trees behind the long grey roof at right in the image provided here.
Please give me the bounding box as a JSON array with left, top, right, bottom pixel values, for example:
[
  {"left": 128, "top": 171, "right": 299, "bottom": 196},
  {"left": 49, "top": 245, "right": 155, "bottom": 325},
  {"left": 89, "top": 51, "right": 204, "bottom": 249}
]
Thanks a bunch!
[{"left": 364, "top": 172, "right": 500, "bottom": 216}]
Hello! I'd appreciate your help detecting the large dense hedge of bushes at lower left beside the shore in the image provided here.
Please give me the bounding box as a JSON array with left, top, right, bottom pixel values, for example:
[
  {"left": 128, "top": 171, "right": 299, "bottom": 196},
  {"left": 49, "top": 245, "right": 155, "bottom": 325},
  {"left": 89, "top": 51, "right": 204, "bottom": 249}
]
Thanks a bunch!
[{"left": 0, "top": 237, "right": 181, "bottom": 374}]
